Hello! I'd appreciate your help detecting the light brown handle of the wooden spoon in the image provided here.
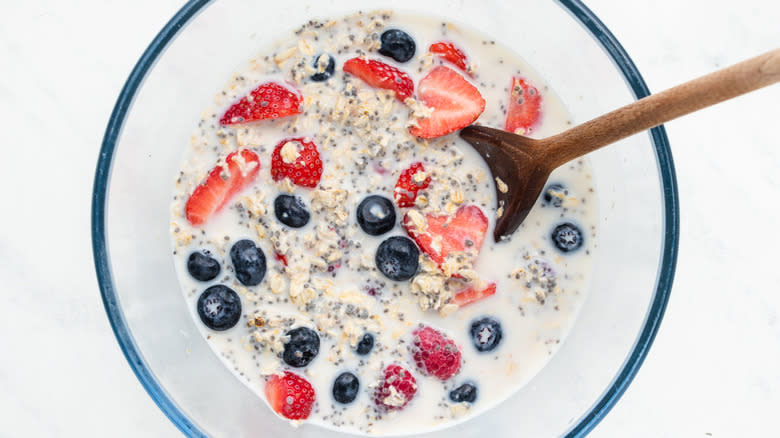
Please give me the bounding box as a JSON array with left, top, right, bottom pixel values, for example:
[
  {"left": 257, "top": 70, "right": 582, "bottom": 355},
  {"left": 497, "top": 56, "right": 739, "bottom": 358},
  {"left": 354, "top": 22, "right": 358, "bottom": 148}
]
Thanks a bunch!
[{"left": 544, "top": 49, "right": 780, "bottom": 167}]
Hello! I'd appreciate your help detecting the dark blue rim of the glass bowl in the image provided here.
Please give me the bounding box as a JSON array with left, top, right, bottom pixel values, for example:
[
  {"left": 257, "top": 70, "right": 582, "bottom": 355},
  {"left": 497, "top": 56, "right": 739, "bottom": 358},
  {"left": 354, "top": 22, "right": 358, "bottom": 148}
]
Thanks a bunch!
[{"left": 92, "top": 0, "right": 680, "bottom": 438}]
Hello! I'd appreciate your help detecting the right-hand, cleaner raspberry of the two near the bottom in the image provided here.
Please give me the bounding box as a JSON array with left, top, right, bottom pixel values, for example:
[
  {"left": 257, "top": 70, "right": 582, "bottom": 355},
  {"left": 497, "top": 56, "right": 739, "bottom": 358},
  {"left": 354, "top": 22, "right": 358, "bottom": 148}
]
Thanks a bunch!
[{"left": 412, "top": 326, "right": 461, "bottom": 380}]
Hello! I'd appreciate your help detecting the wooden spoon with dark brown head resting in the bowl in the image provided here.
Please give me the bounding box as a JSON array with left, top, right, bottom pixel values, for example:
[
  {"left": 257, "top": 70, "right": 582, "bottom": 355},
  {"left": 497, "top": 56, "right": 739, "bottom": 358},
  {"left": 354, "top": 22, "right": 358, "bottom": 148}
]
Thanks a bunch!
[{"left": 460, "top": 49, "right": 780, "bottom": 242}]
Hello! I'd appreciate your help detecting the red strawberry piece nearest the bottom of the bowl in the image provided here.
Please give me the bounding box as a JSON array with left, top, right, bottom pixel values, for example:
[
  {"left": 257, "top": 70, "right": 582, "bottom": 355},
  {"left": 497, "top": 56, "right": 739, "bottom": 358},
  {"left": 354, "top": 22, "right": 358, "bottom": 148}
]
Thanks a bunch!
[{"left": 265, "top": 371, "right": 316, "bottom": 420}]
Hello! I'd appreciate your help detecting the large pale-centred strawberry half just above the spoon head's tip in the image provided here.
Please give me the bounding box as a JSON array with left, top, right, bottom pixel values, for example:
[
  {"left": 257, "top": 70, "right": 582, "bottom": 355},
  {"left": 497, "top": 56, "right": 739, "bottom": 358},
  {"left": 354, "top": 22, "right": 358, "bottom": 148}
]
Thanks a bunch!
[{"left": 409, "top": 66, "right": 485, "bottom": 138}]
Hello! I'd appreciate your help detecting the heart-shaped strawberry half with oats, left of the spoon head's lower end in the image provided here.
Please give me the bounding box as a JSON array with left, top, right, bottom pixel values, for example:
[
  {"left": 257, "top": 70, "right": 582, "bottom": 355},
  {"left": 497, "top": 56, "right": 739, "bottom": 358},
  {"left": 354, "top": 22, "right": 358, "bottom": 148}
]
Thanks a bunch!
[{"left": 404, "top": 205, "right": 488, "bottom": 265}]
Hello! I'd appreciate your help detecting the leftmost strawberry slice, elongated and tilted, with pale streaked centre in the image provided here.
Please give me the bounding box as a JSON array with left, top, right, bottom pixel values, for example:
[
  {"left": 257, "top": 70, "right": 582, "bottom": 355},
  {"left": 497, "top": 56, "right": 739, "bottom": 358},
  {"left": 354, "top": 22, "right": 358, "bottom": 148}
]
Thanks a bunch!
[{"left": 184, "top": 149, "right": 260, "bottom": 225}]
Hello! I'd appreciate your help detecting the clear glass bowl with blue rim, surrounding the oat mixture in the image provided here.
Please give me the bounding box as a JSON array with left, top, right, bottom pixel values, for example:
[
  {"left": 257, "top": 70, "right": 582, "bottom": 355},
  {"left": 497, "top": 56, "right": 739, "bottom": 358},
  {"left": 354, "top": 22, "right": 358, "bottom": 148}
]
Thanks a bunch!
[{"left": 92, "top": 0, "right": 678, "bottom": 437}]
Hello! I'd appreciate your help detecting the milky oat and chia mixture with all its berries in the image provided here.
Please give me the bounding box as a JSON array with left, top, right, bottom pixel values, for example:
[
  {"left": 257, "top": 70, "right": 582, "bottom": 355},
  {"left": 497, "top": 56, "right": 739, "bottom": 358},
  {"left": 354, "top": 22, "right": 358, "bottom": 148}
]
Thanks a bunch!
[{"left": 171, "top": 11, "right": 596, "bottom": 434}]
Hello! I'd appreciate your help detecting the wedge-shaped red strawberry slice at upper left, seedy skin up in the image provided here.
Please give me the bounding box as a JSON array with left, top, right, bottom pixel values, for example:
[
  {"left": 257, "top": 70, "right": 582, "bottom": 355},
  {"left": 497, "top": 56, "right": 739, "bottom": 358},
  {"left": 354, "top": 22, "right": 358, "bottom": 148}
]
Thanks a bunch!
[{"left": 219, "top": 82, "right": 303, "bottom": 125}]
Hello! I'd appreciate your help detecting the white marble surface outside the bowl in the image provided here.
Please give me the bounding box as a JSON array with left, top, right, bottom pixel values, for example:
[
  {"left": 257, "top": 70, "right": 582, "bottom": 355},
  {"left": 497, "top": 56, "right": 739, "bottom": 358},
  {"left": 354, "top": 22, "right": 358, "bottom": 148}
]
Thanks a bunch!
[{"left": 0, "top": 0, "right": 780, "bottom": 437}]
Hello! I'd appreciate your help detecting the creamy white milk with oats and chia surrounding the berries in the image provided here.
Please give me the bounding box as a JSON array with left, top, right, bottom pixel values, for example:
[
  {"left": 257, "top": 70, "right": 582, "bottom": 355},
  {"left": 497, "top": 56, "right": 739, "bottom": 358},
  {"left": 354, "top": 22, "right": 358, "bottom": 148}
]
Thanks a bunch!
[{"left": 171, "top": 9, "right": 597, "bottom": 435}]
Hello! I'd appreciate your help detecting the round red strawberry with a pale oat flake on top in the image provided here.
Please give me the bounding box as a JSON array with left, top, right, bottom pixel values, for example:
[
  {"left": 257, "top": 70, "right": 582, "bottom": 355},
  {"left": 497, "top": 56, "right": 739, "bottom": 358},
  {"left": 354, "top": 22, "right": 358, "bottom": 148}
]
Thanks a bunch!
[{"left": 271, "top": 138, "right": 322, "bottom": 188}]
